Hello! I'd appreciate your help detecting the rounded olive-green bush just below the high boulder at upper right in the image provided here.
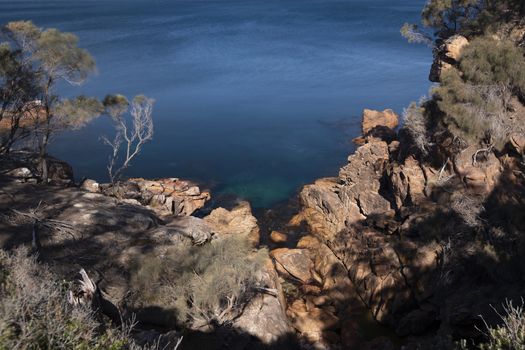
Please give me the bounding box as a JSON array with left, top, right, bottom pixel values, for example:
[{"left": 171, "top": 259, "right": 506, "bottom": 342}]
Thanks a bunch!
[{"left": 433, "top": 37, "right": 525, "bottom": 148}]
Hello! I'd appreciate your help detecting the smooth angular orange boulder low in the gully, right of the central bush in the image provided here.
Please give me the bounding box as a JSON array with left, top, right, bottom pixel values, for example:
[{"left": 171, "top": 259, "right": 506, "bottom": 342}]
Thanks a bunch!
[{"left": 270, "top": 248, "right": 313, "bottom": 282}]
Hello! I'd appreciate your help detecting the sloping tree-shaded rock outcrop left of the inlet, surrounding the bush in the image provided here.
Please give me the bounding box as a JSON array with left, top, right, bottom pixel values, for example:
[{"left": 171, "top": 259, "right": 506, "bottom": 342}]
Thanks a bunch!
[{"left": 0, "top": 157, "right": 296, "bottom": 349}]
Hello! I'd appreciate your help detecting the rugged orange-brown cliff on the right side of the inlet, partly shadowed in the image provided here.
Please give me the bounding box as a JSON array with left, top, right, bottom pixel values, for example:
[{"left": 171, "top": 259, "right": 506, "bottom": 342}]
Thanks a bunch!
[{"left": 272, "top": 100, "right": 525, "bottom": 349}]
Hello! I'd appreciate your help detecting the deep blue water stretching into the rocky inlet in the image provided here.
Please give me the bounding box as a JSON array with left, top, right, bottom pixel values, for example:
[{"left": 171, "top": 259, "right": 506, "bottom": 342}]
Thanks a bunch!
[{"left": 0, "top": 0, "right": 431, "bottom": 207}]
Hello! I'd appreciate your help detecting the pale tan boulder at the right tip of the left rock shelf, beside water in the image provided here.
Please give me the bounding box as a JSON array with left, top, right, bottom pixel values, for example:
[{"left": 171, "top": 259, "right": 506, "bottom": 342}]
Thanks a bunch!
[{"left": 204, "top": 202, "right": 259, "bottom": 245}]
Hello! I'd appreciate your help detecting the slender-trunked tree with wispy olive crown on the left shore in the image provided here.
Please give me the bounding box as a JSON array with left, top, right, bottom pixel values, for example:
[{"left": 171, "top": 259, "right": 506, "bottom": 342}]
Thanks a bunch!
[{"left": 2, "top": 21, "right": 103, "bottom": 181}]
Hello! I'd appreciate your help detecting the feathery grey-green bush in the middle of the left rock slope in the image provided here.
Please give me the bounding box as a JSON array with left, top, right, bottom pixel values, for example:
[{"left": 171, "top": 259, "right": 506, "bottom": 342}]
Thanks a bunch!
[{"left": 132, "top": 236, "right": 267, "bottom": 324}]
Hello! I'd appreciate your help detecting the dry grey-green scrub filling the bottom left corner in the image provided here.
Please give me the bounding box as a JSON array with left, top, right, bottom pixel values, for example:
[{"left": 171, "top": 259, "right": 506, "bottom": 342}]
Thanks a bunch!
[{"left": 0, "top": 249, "right": 157, "bottom": 350}]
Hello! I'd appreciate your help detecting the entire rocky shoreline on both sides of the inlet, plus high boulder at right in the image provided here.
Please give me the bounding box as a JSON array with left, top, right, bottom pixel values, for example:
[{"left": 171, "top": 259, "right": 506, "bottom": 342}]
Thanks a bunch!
[{"left": 0, "top": 36, "right": 525, "bottom": 349}]
